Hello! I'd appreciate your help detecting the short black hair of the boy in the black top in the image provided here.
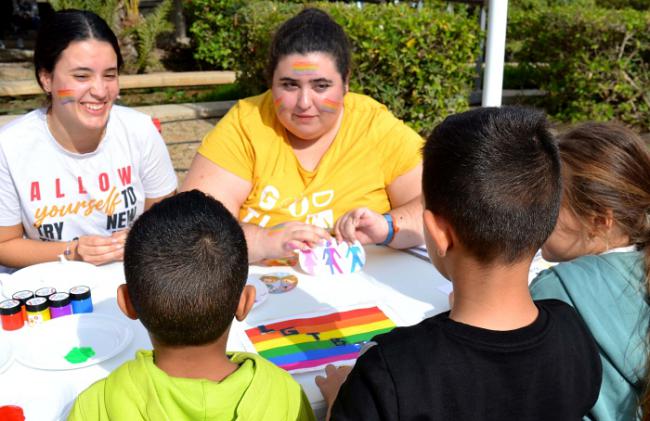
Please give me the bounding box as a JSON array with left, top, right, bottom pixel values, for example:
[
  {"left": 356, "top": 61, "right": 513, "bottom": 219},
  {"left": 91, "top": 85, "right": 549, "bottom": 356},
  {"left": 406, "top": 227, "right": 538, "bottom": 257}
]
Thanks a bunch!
[{"left": 422, "top": 107, "right": 562, "bottom": 263}]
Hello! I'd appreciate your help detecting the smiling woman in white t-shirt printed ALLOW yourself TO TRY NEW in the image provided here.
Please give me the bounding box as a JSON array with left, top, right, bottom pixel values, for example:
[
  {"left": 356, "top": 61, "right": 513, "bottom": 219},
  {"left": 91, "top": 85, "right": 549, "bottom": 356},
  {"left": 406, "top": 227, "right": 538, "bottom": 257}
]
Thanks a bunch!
[{"left": 0, "top": 10, "right": 177, "bottom": 268}]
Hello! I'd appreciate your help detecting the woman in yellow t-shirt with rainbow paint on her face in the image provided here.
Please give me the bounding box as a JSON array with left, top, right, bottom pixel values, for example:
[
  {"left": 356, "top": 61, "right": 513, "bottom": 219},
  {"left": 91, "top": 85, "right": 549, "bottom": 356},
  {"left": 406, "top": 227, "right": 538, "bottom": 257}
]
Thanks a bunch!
[{"left": 182, "top": 9, "right": 423, "bottom": 262}]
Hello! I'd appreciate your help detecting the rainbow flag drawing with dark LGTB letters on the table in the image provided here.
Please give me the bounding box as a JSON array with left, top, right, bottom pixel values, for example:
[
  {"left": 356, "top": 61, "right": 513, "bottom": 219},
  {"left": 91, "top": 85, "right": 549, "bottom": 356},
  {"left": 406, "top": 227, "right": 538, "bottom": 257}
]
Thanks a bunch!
[{"left": 245, "top": 307, "right": 395, "bottom": 371}]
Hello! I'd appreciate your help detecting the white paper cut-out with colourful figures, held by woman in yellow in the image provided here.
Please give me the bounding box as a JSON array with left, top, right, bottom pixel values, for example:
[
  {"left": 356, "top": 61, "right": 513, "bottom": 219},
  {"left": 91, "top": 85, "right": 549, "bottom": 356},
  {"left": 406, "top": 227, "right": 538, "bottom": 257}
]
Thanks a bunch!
[{"left": 298, "top": 239, "right": 366, "bottom": 275}]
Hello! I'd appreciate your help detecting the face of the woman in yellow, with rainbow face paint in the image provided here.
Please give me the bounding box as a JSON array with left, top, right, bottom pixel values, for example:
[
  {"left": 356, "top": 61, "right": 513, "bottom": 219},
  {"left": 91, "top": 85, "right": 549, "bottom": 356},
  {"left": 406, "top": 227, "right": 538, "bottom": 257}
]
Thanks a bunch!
[{"left": 271, "top": 52, "right": 347, "bottom": 140}]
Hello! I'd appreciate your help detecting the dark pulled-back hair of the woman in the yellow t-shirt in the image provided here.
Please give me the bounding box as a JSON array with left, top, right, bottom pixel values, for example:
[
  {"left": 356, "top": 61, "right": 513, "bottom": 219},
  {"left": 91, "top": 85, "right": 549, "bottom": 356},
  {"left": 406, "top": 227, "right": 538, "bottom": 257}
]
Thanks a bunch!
[{"left": 266, "top": 8, "right": 352, "bottom": 85}]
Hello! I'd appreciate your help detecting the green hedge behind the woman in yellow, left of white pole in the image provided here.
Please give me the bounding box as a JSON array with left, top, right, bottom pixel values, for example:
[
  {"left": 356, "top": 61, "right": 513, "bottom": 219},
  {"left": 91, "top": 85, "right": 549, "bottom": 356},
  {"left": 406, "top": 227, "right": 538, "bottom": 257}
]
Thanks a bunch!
[{"left": 185, "top": 0, "right": 481, "bottom": 134}]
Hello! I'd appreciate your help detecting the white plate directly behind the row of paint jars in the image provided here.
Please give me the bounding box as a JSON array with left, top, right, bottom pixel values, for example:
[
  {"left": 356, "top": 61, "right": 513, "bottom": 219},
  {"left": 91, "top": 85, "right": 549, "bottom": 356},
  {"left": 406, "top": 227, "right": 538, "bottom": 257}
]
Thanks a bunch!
[{"left": 0, "top": 261, "right": 101, "bottom": 298}]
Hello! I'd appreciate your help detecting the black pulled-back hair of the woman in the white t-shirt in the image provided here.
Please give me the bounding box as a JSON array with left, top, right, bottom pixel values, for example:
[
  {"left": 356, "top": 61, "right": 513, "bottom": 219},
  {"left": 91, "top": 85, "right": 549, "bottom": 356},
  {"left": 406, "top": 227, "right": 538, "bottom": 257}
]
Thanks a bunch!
[{"left": 34, "top": 9, "right": 124, "bottom": 88}]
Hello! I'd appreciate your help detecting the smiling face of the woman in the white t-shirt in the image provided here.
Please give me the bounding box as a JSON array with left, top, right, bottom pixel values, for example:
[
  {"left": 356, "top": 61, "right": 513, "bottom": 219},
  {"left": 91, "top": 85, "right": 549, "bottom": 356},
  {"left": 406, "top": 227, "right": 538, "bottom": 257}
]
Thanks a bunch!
[{"left": 40, "top": 39, "right": 120, "bottom": 132}]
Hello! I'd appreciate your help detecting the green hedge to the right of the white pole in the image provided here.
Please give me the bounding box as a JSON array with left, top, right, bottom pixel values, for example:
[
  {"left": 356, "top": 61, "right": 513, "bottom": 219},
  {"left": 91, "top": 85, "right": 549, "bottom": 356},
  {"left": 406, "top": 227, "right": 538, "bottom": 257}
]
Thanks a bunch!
[{"left": 508, "top": 6, "right": 650, "bottom": 130}]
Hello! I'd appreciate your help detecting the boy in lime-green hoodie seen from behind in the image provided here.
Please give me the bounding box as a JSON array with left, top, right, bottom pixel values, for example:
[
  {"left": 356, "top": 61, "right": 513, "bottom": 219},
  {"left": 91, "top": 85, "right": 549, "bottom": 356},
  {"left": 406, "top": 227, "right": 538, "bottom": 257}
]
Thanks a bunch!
[{"left": 69, "top": 190, "right": 314, "bottom": 420}]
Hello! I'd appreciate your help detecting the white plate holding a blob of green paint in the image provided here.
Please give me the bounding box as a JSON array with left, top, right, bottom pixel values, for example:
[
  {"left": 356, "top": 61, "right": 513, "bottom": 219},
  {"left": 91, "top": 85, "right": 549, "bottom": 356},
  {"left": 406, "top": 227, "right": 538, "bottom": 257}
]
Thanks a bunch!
[{"left": 14, "top": 313, "right": 133, "bottom": 370}]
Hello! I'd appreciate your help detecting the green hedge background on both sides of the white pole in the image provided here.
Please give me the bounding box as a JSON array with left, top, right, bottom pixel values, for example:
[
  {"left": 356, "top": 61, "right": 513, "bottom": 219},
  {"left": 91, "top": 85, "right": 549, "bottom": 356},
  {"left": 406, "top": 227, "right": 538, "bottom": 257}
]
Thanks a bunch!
[{"left": 185, "top": 0, "right": 650, "bottom": 133}]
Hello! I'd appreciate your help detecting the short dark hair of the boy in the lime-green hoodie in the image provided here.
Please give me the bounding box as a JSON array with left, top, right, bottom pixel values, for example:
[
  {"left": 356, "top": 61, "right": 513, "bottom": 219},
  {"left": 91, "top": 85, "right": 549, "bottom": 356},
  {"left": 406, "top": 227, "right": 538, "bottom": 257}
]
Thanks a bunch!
[{"left": 124, "top": 190, "right": 248, "bottom": 346}]
